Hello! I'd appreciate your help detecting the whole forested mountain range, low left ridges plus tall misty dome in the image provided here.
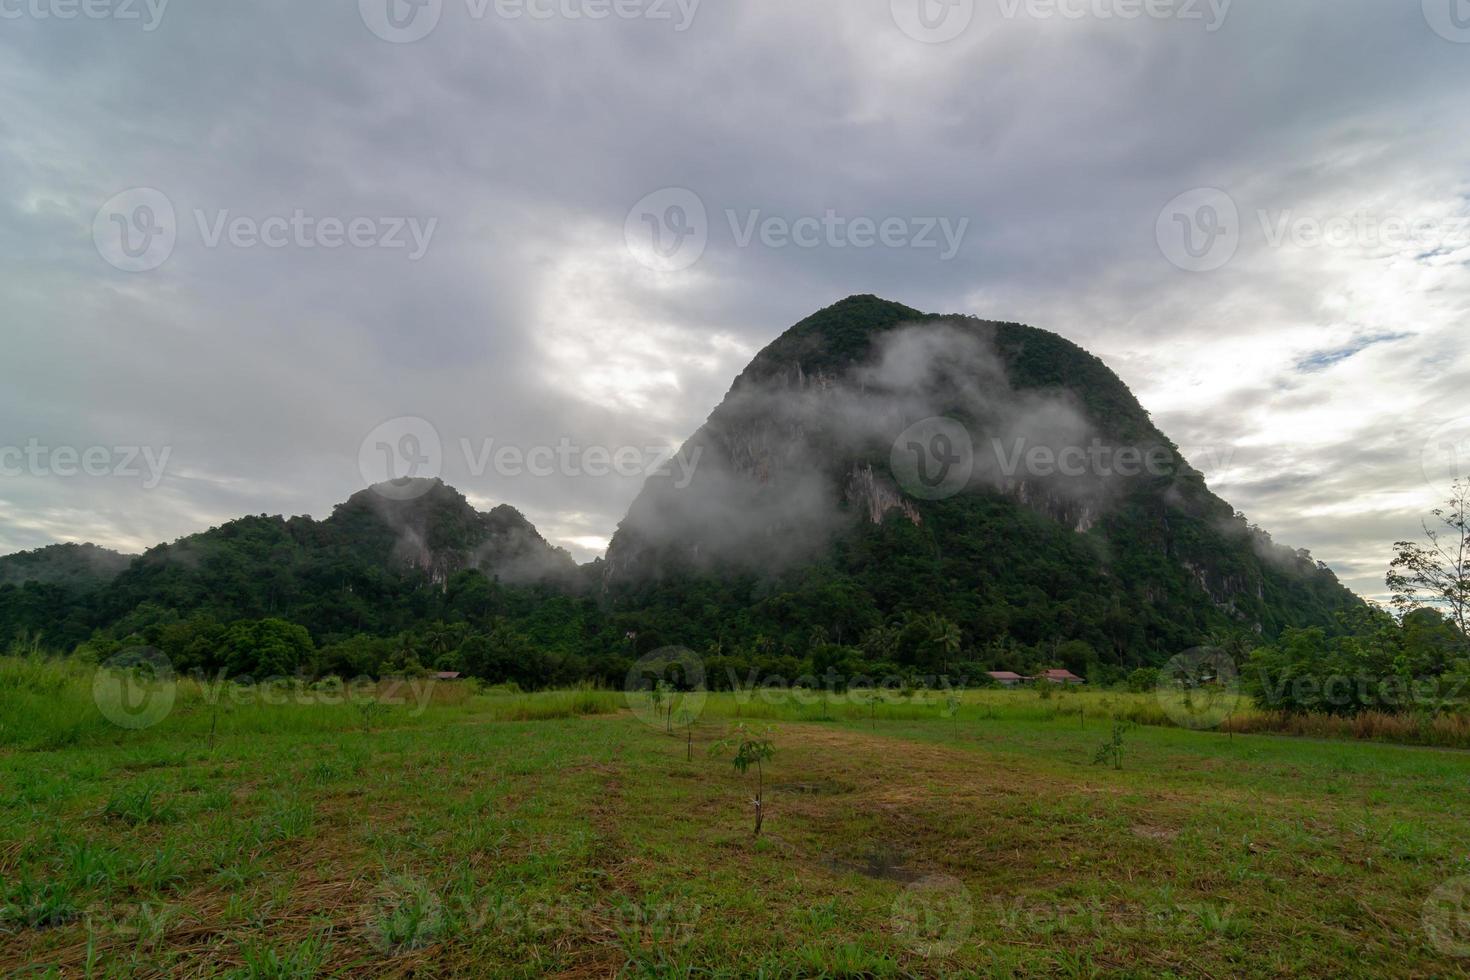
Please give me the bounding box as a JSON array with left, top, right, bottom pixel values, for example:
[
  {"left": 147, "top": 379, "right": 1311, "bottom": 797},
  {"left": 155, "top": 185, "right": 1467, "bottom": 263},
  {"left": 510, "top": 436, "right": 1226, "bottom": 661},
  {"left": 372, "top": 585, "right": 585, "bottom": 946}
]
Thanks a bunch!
[{"left": 0, "top": 297, "right": 1360, "bottom": 685}]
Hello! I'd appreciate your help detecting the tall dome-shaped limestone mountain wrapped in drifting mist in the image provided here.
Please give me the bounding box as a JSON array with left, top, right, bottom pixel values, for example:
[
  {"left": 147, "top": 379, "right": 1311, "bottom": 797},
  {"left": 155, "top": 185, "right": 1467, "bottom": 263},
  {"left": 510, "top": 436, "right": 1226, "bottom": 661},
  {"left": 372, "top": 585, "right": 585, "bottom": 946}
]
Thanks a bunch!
[{"left": 604, "top": 290, "right": 1357, "bottom": 663}]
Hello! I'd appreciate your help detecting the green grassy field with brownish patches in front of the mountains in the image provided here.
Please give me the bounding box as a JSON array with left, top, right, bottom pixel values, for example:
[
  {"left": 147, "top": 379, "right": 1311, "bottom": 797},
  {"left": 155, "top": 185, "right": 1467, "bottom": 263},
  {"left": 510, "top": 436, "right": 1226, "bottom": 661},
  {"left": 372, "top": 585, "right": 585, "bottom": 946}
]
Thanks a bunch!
[{"left": 0, "top": 663, "right": 1470, "bottom": 977}]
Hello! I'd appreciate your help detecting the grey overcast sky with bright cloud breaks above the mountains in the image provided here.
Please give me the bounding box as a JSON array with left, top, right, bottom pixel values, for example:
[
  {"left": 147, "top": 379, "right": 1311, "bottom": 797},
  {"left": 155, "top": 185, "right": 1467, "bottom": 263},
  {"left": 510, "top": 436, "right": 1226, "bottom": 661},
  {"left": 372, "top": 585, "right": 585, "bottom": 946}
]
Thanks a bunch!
[{"left": 0, "top": 0, "right": 1470, "bottom": 595}]
